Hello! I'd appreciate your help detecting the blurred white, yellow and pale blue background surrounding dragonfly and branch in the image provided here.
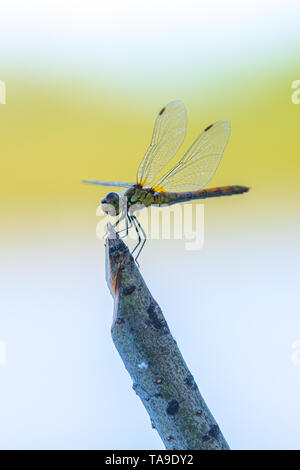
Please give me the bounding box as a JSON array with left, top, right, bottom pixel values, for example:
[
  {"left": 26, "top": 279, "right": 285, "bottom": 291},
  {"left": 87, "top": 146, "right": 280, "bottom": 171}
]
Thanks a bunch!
[{"left": 0, "top": 0, "right": 300, "bottom": 449}]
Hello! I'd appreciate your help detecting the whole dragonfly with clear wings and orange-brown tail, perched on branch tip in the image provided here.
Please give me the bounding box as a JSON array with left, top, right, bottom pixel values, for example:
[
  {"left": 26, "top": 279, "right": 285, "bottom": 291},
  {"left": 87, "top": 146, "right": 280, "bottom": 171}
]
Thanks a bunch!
[{"left": 83, "top": 101, "right": 250, "bottom": 264}]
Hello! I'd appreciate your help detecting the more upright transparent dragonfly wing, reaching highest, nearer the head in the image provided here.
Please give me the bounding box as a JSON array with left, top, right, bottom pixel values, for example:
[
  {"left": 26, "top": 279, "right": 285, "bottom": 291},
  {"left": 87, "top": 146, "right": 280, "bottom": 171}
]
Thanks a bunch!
[{"left": 137, "top": 101, "right": 187, "bottom": 186}]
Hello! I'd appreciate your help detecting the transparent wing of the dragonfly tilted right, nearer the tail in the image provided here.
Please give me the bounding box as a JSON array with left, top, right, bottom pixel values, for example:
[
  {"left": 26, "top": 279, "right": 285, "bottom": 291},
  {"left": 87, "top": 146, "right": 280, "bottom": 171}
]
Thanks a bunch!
[{"left": 155, "top": 121, "right": 230, "bottom": 192}]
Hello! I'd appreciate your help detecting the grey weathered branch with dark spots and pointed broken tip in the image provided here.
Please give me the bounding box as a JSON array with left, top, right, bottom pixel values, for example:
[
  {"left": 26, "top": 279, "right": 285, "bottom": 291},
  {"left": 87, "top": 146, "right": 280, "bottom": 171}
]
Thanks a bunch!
[{"left": 106, "top": 226, "right": 229, "bottom": 450}]
